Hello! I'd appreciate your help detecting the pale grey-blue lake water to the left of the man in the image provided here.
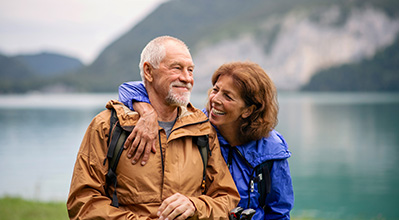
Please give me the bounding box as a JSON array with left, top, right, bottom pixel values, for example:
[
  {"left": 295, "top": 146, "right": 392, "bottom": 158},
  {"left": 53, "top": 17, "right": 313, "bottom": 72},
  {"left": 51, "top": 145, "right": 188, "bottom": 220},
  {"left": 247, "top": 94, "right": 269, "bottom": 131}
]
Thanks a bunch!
[{"left": 0, "top": 94, "right": 117, "bottom": 200}]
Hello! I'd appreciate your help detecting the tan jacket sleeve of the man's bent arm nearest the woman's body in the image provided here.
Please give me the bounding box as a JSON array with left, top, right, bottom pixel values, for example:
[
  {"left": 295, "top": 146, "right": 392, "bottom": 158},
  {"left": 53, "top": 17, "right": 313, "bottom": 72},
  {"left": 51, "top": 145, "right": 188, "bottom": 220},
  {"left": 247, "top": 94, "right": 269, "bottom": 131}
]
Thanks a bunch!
[{"left": 190, "top": 132, "right": 240, "bottom": 219}]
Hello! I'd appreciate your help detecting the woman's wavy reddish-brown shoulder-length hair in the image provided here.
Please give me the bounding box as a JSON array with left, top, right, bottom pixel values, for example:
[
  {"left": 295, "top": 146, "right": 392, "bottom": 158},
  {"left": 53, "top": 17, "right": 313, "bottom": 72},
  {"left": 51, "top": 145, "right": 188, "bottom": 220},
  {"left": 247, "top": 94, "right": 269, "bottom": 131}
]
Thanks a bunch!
[{"left": 212, "top": 62, "right": 278, "bottom": 142}]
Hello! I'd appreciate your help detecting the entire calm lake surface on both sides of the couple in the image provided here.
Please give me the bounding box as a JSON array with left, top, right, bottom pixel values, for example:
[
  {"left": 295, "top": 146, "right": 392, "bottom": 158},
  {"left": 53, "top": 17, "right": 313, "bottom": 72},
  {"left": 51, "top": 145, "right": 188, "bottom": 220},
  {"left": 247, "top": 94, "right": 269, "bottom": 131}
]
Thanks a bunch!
[{"left": 0, "top": 93, "right": 399, "bottom": 219}]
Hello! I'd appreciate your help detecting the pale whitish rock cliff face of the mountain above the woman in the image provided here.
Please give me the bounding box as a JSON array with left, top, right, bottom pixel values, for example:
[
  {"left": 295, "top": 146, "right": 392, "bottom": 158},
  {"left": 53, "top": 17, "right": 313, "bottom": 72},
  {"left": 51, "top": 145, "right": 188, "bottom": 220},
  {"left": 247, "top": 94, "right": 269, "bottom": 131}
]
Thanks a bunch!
[{"left": 189, "top": 1, "right": 399, "bottom": 90}]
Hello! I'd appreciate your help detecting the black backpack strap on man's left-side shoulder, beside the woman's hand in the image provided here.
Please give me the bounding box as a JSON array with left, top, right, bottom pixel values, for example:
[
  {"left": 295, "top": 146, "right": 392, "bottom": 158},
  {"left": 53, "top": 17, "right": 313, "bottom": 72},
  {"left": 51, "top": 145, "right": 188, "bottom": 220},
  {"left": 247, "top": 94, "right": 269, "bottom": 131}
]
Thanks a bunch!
[{"left": 104, "top": 109, "right": 128, "bottom": 207}]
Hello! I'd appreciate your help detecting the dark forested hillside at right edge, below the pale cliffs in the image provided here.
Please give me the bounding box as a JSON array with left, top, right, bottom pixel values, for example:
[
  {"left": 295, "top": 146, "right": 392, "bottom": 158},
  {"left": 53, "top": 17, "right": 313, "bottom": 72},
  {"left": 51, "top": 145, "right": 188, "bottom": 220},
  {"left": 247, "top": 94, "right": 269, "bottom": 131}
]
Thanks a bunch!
[{"left": 303, "top": 36, "right": 399, "bottom": 91}]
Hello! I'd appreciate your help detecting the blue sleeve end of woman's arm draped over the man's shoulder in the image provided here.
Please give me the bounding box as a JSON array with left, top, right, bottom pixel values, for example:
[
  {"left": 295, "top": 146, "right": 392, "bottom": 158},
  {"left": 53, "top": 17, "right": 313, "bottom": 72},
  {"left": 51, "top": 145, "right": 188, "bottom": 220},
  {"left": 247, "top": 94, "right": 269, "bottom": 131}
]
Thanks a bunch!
[{"left": 119, "top": 81, "right": 151, "bottom": 110}]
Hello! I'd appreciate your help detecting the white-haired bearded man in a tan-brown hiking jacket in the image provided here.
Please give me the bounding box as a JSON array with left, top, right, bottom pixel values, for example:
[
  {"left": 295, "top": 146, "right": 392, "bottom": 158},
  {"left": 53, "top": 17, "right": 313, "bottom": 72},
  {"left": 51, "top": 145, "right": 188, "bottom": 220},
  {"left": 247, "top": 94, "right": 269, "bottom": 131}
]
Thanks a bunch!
[{"left": 67, "top": 36, "right": 240, "bottom": 220}]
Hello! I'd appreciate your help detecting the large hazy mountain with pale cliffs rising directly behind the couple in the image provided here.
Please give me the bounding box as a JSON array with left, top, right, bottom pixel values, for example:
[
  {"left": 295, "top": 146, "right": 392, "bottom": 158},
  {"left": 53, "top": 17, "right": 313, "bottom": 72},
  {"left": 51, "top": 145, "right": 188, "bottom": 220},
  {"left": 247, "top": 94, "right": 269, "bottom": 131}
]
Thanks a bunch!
[{"left": 75, "top": 0, "right": 399, "bottom": 92}]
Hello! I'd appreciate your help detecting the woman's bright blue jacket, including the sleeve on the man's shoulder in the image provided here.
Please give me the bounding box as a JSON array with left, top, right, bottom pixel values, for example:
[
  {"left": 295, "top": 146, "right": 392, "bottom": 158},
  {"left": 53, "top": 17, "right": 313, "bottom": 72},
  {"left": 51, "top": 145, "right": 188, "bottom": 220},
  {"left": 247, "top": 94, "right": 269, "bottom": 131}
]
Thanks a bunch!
[{"left": 119, "top": 82, "right": 294, "bottom": 220}]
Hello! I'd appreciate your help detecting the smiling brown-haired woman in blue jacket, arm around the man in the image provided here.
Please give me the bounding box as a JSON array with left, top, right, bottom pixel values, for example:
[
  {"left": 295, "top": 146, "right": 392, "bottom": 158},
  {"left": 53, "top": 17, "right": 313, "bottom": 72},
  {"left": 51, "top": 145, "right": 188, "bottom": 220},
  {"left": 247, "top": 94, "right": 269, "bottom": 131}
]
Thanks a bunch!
[{"left": 119, "top": 62, "right": 294, "bottom": 219}]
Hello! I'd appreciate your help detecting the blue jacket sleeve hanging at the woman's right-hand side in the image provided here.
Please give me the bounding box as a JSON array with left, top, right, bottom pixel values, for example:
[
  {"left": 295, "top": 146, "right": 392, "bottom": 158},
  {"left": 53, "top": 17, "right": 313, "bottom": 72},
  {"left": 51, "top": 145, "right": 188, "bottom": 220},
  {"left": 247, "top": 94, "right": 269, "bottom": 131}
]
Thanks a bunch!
[{"left": 264, "top": 159, "right": 294, "bottom": 219}]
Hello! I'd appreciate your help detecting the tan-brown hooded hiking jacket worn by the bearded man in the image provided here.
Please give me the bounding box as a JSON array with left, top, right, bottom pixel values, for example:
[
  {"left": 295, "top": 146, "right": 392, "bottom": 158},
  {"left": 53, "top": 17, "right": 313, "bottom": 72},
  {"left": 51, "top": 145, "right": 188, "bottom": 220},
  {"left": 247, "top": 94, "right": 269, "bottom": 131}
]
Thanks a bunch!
[{"left": 67, "top": 100, "right": 240, "bottom": 219}]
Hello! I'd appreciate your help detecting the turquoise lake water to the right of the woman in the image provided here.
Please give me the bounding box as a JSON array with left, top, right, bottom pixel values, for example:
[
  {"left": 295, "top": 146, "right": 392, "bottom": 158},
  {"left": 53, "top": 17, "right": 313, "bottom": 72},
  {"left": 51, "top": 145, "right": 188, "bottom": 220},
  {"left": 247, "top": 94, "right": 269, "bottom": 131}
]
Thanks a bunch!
[{"left": 277, "top": 94, "right": 399, "bottom": 219}]
